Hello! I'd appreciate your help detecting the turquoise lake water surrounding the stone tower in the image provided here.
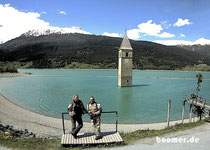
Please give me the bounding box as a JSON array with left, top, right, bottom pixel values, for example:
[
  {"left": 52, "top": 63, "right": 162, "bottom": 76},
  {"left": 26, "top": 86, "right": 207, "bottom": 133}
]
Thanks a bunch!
[{"left": 0, "top": 69, "right": 210, "bottom": 123}]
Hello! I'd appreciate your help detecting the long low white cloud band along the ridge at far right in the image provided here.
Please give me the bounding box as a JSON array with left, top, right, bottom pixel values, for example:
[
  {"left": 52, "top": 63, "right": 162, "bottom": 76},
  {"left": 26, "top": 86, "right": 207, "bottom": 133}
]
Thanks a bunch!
[{"left": 153, "top": 38, "right": 210, "bottom": 45}]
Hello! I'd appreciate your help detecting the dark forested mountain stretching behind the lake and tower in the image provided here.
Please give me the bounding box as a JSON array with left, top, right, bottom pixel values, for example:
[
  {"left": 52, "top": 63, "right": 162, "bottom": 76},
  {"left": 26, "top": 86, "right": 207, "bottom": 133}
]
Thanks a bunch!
[{"left": 0, "top": 31, "right": 210, "bottom": 70}]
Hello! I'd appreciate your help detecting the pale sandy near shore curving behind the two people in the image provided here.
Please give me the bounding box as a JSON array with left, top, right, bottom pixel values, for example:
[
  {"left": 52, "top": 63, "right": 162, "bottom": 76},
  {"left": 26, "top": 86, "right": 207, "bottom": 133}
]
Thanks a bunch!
[{"left": 0, "top": 94, "right": 198, "bottom": 138}]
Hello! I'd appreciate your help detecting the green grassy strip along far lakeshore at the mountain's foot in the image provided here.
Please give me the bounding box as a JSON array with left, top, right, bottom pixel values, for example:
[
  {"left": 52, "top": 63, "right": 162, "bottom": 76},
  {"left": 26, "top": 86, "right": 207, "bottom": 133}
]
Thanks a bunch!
[{"left": 0, "top": 62, "right": 210, "bottom": 73}]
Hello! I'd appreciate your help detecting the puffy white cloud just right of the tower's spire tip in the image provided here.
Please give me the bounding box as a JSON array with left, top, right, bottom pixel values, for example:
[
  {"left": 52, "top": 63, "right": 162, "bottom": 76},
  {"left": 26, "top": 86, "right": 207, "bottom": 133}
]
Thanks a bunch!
[{"left": 127, "top": 20, "right": 175, "bottom": 39}]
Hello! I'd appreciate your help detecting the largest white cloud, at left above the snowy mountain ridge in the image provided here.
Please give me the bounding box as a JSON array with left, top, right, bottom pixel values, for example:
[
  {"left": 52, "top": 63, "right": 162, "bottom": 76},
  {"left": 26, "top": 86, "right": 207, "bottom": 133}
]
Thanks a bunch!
[{"left": 0, "top": 4, "right": 90, "bottom": 42}]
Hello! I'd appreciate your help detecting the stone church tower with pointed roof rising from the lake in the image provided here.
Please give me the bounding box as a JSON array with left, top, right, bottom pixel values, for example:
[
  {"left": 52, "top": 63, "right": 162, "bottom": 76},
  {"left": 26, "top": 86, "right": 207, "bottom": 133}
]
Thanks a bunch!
[{"left": 118, "top": 33, "right": 133, "bottom": 87}]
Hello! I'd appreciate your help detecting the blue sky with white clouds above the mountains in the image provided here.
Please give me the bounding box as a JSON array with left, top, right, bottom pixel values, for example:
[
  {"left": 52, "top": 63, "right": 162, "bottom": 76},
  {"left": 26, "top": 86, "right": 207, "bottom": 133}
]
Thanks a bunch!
[{"left": 0, "top": 0, "right": 210, "bottom": 45}]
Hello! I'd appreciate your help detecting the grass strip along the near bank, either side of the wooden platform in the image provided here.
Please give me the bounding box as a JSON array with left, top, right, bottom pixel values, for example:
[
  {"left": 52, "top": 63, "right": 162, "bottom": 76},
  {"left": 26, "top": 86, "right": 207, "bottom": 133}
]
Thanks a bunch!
[{"left": 0, "top": 119, "right": 210, "bottom": 150}]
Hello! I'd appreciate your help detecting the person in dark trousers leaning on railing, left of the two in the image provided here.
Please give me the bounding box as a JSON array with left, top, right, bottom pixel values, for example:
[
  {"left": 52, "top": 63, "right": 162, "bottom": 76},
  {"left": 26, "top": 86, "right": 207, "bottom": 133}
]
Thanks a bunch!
[{"left": 68, "top": 95, "right": 87, "bottom": 138}]
